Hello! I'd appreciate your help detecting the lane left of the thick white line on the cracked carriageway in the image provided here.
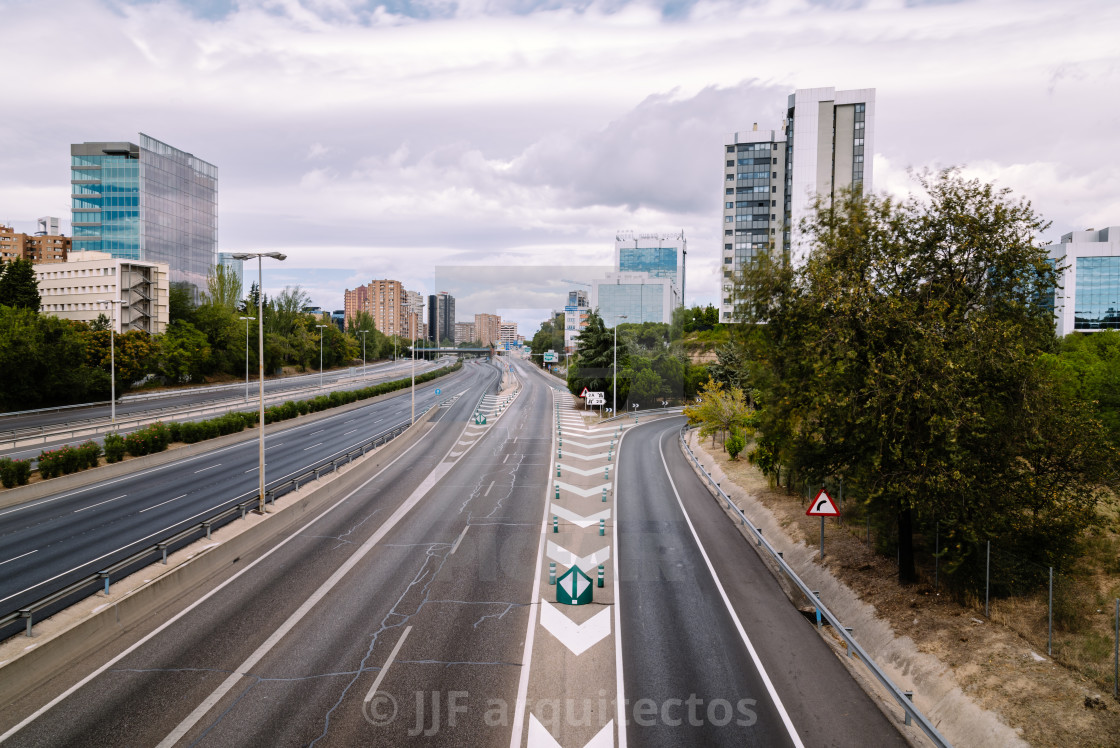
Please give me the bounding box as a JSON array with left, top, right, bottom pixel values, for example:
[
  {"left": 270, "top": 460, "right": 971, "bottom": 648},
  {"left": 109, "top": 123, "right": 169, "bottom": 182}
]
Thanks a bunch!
[{"left": 0, "top": 362, "right": 499, "bottom": 746}]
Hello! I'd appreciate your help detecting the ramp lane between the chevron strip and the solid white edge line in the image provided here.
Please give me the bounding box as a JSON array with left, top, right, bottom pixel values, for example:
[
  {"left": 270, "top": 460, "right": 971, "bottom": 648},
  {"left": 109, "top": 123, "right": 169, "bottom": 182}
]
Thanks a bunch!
[{"left": 617, "top": 421, "right": 794, "bottom": 746}]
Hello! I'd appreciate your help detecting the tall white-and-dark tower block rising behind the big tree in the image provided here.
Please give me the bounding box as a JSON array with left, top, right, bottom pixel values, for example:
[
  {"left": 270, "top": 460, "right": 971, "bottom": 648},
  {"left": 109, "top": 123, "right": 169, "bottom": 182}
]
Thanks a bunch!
[{"left": 720, "top": 88, "right": 875, "bottom": 321}]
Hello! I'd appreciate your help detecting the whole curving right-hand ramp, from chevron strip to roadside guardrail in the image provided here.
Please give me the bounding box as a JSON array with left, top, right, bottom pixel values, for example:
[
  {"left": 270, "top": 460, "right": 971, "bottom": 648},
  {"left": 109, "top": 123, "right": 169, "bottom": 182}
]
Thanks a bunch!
[{"left": 618, "top": 418, "right": 907, "bottom": 747}]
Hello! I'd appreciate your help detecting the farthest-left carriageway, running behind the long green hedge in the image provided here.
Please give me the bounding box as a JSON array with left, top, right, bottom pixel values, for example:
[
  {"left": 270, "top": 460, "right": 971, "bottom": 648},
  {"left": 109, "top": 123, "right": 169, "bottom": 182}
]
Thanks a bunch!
[{"left": 0, "top": 358, "right": 450, "bottom": 460}]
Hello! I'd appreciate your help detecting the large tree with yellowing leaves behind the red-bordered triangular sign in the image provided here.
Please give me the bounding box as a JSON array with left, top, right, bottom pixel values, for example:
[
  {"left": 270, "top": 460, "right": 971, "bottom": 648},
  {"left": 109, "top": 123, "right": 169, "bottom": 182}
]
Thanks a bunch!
[{"left": 737, "top": 170, "right": 1109, "bottom": 583}]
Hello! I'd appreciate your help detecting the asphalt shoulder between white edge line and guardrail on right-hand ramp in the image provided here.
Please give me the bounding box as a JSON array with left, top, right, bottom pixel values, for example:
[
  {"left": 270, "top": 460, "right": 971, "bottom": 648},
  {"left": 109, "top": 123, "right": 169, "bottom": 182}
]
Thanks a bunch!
[{"left": 661, "top": 419, "right": 908, "bottom": 748}]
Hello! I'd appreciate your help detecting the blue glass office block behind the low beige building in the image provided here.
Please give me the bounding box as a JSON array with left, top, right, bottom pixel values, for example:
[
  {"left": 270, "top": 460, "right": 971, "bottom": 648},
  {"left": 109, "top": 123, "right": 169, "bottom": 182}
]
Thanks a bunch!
[{"left": 71, "top": 133, "right": 217, "bottom": 293}]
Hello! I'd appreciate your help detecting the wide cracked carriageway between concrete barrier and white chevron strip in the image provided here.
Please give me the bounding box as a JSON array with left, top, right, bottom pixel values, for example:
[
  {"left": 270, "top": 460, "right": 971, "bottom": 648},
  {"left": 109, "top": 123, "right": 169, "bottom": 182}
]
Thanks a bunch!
[{"left": 0, "top": 356, "right": 552, "bottom": 746}]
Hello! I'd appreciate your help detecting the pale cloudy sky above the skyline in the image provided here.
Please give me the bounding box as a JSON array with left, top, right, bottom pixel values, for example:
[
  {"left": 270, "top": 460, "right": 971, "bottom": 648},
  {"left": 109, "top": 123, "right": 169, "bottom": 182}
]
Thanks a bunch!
[{"left": 0, "top": 0, "right": 1120, "bottom": 335}]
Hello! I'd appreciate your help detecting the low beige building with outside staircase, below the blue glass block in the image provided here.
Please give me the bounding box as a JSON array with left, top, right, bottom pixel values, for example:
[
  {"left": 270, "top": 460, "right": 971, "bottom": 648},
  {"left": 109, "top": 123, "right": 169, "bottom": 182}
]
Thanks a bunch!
[{"left": 35, "top": 251, "right": 169, "bottom": 335}]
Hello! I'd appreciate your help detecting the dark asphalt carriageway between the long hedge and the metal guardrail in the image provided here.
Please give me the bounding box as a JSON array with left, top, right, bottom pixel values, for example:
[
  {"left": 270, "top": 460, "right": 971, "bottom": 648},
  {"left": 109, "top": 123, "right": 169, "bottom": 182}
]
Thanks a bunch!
[{"left": 0, "top": 364, "right": 477, "bottom": 627}]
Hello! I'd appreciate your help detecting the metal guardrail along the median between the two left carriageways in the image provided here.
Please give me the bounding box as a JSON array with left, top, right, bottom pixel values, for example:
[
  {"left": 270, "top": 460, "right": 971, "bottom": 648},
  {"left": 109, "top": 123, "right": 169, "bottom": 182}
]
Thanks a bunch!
[{"left": 0, "top": 414, "right": 431, "bottom": 638}]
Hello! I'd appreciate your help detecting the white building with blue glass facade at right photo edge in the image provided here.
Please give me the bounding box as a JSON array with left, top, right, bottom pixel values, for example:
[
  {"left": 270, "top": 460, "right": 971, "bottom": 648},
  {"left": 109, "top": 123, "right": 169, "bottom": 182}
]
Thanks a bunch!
[{"left": 1049, "top": 226, "right": 1120, "bottom": 335}]
